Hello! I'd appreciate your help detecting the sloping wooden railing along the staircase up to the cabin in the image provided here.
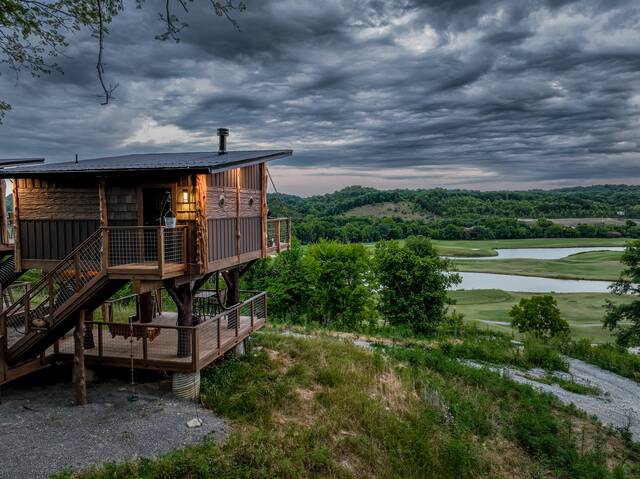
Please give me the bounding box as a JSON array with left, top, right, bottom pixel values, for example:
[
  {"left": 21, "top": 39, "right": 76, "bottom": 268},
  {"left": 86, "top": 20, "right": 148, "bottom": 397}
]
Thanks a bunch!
[{"left": 0, "top": 228, "right": 104, "bottom": 346}]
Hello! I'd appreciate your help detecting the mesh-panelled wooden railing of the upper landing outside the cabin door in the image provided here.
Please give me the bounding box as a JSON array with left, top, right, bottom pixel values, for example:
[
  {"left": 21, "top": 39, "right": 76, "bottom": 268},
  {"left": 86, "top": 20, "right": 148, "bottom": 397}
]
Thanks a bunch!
[{"left": 104, "top": 226, "right": 187, "bottom": 275}]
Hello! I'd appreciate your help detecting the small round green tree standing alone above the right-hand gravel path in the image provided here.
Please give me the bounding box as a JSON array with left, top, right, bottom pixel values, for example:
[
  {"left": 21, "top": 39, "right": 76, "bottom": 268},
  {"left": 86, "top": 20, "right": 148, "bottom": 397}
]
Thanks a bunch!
[{"left": 509, "top": 294, "right": 569, "bottom": 340}]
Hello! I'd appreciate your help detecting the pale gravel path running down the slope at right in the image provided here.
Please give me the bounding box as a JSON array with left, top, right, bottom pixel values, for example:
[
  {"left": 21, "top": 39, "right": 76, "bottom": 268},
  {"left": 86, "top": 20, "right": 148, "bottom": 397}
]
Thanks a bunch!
[{"left": 464, "top": 358, "right": 640, "bottom": 441}]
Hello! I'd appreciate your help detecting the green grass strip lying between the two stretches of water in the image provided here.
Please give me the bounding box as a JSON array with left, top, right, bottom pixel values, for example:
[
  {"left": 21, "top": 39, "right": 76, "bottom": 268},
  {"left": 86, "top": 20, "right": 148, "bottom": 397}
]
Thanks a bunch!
[{"left": 454, "top": 251, "right": 623, "bottom": 281}]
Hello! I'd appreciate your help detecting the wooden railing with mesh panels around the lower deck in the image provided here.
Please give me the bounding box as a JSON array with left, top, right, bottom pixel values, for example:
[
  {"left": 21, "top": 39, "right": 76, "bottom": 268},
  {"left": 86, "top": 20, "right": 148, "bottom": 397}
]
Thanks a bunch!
[{"left": 54, "top": 291, "right": 267, "bottom": 371}]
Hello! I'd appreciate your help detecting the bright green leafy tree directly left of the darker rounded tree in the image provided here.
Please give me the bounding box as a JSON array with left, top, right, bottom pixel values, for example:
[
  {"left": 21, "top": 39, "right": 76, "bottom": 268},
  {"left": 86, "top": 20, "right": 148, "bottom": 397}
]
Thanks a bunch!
[{"left": 305, "top": 241, "right": 373, "bottom": 329}]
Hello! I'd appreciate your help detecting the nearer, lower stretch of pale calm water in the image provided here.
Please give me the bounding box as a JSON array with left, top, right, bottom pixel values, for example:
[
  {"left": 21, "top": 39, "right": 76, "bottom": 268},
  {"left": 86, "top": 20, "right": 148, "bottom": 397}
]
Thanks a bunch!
[{"left": 452, "top": 272, "right": 611, "bottom": 293}]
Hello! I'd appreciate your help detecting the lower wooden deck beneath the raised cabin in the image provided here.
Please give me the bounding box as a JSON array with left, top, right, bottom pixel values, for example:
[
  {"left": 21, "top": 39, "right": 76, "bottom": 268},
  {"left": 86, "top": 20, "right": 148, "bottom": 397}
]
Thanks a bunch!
[{"left": 51, "top": 313, "right": 265, "bottom": 372}]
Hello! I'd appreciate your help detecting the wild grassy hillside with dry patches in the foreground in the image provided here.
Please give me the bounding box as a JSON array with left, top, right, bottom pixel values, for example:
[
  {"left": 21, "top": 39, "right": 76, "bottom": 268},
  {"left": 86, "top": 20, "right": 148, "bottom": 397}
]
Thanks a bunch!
[{"left": 56, "top": 332, "right": 640, "bottom": 479}]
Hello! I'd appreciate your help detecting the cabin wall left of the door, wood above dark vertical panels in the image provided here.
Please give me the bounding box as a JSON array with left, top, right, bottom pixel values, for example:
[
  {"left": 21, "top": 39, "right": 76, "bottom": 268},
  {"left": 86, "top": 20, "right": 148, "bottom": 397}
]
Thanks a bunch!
[{"left": 16, "top": 178, "right": 100, "bottom": 267}]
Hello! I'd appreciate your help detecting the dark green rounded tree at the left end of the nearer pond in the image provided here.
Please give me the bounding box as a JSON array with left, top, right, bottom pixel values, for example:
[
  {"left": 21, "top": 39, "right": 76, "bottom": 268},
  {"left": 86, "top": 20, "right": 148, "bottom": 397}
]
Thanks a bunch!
[{"left": 374, "top": 238, "right": 460, "bottom": 333}]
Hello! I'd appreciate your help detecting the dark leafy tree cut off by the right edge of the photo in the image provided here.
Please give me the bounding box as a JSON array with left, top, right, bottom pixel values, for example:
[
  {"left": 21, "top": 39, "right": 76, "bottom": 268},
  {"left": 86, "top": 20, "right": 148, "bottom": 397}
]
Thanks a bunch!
[{"left": 604, "top": 240, "right": 640, "bottom": 346}]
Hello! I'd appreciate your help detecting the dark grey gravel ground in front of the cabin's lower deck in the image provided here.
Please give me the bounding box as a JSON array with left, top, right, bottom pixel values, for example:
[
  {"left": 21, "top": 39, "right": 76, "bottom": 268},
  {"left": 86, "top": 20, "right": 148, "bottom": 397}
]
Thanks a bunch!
[{"left": 0, "top": 380, "right": 227, "bottom": 479}]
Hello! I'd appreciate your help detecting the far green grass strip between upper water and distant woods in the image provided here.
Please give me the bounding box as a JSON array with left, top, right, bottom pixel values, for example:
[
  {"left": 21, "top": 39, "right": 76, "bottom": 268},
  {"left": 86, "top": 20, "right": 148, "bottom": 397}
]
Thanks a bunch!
[{"left": 433, "top": 238, "right": 629, "bottom": 257}]
